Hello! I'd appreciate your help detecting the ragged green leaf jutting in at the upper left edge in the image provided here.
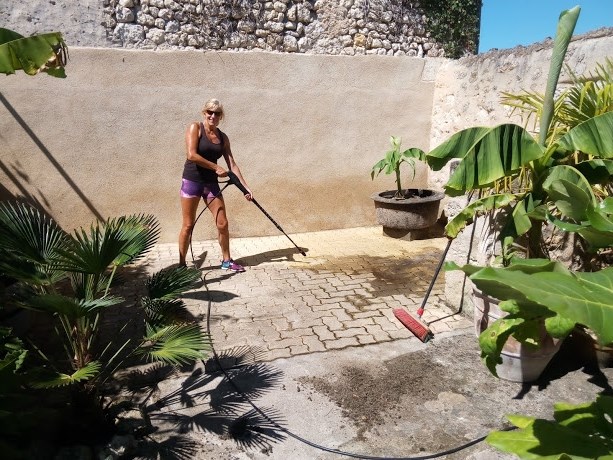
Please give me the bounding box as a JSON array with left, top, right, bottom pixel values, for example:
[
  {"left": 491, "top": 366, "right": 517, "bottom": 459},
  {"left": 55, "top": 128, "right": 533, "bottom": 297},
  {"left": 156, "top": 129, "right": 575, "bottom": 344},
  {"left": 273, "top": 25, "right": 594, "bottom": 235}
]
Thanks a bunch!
[{"left": 0, "top": 28, "right": 68, "bottom": 78}]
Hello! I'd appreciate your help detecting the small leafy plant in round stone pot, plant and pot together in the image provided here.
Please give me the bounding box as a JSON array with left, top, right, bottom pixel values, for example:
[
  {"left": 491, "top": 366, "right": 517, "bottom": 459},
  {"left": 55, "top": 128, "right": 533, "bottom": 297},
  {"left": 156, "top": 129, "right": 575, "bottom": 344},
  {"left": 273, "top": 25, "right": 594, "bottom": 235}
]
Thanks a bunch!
[{"left": 370, "top": 136, "right": 444, "bottom": 237}]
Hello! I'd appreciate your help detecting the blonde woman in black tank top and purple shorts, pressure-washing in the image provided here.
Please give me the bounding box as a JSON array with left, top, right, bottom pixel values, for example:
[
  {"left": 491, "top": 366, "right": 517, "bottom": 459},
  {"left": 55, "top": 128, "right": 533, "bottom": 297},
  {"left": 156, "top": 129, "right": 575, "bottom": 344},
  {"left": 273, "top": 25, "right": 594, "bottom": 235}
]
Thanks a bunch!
[{"left": 179, "top": 99, "right": 253, "bottom": 272}]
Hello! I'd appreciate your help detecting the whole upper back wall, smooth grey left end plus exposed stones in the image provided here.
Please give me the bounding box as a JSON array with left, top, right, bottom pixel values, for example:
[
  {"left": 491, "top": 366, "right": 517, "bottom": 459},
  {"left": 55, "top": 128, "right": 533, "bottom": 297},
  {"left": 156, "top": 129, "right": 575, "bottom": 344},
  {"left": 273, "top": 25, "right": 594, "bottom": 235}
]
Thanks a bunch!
[{"left": 0, "top": 0, "right": 444, "bottom": 57}]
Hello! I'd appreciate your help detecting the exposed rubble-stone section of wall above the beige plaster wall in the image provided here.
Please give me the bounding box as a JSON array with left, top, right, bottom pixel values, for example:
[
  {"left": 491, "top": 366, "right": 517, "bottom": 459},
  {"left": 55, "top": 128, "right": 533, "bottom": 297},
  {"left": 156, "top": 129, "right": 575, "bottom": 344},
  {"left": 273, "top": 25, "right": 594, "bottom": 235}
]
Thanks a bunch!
[{"left": 104, "top": 0, "right": 444, "bottom": 57}]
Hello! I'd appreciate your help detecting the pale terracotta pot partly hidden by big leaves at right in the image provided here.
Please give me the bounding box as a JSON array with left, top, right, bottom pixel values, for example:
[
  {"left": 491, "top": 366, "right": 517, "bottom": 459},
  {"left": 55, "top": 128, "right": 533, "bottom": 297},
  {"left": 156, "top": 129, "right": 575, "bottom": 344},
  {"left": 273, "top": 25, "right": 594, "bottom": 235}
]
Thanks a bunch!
[{"left": 473, "top": 287, "right": 562, "bottom": 382}]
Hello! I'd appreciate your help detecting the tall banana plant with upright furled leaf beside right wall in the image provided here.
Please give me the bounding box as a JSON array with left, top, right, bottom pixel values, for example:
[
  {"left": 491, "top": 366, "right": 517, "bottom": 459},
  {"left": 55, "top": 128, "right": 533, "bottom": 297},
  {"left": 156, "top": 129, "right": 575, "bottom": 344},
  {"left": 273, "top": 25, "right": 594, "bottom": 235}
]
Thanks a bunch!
[{"left": 426, "top": 7, "right": 613, "bottom": 257}]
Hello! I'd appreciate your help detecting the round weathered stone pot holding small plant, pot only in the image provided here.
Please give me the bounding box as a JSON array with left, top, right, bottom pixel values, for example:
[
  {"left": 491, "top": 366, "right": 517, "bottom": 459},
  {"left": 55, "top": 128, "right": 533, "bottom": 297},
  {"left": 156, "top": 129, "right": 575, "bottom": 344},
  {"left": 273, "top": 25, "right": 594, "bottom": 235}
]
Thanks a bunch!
[{"left": 370, "top": 189, "right": 445, "bottom": 230}]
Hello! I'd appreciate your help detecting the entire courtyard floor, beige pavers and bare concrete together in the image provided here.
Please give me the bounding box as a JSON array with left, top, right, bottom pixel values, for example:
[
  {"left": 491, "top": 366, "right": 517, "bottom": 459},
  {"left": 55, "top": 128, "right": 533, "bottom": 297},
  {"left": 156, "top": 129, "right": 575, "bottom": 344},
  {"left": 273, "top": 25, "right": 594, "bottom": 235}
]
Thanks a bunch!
[{"left": 126, "top": 227, "right": 613, "bottom": 460}]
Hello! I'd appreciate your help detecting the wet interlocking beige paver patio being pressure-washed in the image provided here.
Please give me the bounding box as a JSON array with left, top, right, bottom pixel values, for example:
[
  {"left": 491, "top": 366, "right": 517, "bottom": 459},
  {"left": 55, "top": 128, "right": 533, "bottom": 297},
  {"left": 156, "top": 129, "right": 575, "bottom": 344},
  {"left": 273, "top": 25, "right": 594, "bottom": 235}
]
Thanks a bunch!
[{"left": 136, "top": 227, "right": 472, "bottom": 361}]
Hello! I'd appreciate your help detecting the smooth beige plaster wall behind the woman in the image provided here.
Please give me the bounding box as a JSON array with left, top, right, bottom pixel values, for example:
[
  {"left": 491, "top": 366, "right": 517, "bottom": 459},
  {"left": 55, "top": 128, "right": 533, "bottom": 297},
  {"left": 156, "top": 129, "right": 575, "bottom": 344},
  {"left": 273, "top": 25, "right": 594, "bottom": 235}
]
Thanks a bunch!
[{"left": 0, "top": 47, "right": 442, "bottom": 242}]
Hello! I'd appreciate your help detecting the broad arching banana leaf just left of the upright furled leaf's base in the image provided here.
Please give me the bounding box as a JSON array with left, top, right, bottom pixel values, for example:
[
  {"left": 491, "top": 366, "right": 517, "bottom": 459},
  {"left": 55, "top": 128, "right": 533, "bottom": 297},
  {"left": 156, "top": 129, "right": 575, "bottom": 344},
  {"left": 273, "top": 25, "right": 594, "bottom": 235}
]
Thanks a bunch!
[{"left": 428, "top": 124, "right": 544, "bottom": 196}]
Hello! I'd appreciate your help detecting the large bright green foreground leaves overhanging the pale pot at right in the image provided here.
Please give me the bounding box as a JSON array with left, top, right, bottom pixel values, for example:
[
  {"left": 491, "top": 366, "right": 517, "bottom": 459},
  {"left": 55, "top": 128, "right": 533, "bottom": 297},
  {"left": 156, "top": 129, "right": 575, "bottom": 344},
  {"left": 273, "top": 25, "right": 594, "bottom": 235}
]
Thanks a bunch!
[{"left": 446, "top": 256, "right": 613, "bottom": 375}]
